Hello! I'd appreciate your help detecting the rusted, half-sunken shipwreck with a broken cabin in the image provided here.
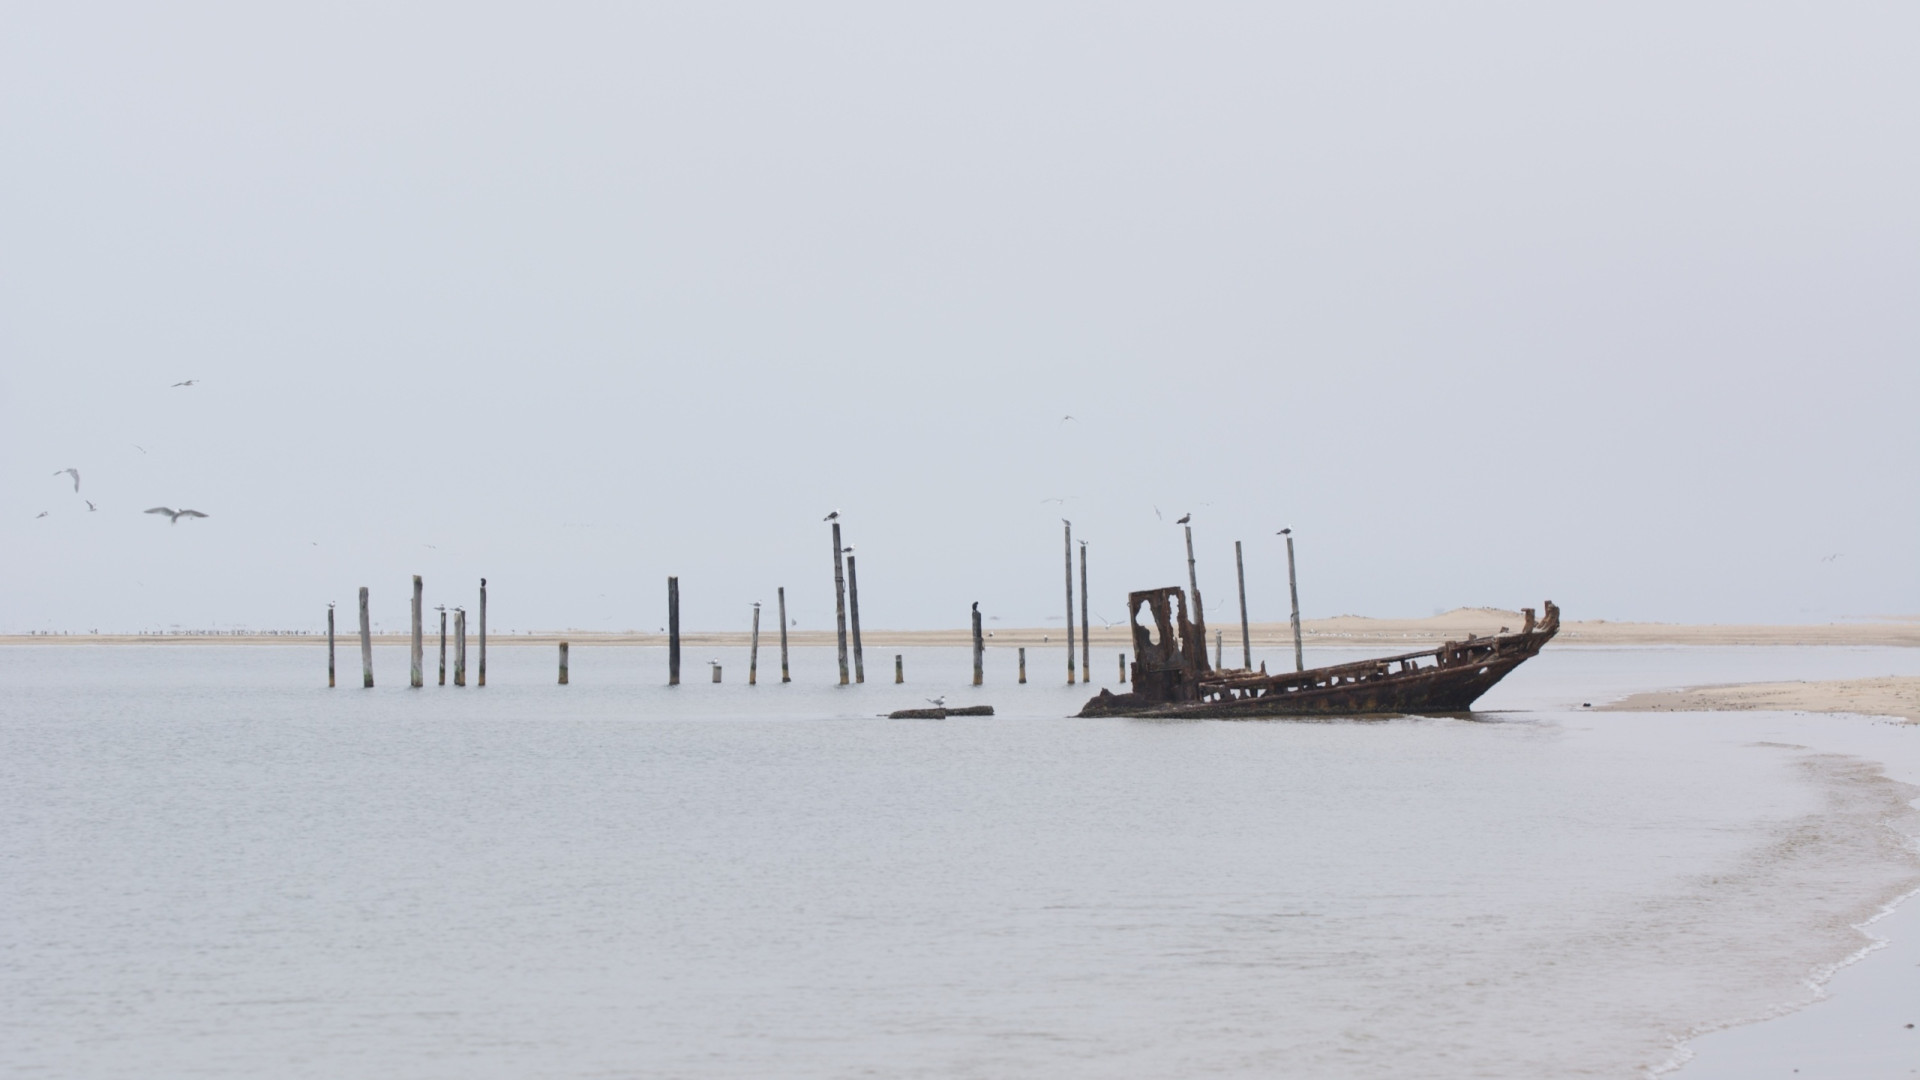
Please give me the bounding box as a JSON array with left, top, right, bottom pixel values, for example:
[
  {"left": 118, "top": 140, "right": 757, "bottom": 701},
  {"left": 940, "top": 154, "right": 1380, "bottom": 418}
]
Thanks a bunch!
[{"left": 1079, "top": 588, "right": 1559, "bottom": 719}]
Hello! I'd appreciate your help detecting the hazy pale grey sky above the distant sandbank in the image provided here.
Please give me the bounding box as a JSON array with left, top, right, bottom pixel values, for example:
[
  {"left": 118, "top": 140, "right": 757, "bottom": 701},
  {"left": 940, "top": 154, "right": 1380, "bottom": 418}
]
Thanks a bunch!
[{"left": 0, "top": 2, "right": 1920, "bottom": 630}]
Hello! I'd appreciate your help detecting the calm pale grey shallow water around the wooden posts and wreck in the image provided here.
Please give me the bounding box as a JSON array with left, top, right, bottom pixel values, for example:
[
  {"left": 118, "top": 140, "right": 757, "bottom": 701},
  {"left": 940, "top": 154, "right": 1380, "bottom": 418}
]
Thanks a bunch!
[{"left": 0, "top": 646, "right": 1920, "bottom": 1076}]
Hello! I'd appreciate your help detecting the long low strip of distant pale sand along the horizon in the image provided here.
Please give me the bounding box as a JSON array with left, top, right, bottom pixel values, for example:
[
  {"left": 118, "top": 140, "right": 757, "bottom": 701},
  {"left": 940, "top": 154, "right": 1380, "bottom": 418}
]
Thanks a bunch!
[{"left": 0, "top": 607, "right": 1920, "bottom": 651}]
